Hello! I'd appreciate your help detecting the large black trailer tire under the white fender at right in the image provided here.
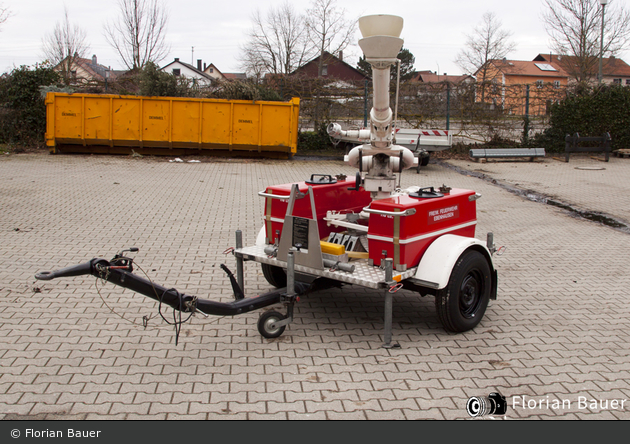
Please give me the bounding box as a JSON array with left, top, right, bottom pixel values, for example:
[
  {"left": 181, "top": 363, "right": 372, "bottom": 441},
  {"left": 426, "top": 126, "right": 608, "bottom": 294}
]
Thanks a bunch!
[{"left": 435, "top": 250, "right": 492, "bottom": 333}]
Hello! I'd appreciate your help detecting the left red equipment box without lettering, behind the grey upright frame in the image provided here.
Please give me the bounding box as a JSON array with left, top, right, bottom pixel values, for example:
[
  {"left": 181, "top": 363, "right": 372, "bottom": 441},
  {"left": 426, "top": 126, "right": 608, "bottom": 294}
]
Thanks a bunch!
[{"left": 265, "top": 176, "right": 372, "bottom": 243}]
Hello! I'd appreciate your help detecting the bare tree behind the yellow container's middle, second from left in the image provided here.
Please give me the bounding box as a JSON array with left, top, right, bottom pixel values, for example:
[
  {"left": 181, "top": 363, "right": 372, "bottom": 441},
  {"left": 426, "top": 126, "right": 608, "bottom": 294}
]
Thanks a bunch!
[{"left": 105, "top": 0, "right": 169, "bottom": 69}]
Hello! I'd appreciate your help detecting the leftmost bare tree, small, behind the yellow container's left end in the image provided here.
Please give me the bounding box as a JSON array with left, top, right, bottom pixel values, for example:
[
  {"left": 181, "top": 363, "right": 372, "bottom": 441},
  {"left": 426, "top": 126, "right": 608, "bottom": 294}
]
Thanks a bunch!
[{"left": 42, "top": 7, "right": 89, "bottom": 84}]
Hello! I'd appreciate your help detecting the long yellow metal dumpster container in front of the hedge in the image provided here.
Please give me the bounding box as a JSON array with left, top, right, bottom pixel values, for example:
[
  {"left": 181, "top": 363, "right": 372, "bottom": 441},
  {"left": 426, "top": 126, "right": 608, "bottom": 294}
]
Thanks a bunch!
[{"left": 46, "top": 93, "right": 300, "bottom": 157}]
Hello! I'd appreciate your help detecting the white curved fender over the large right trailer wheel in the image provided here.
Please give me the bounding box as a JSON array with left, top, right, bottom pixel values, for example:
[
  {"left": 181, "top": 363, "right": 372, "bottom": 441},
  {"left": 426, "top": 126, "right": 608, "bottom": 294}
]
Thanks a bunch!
[{"left": 414, "top": 234, "right": 494, "bottom": 290}]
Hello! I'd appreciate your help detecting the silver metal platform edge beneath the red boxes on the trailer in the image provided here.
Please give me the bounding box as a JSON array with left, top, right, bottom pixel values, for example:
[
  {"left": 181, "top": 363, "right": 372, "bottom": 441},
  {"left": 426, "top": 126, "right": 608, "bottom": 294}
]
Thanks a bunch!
[{"left": 234, "top": 246, "right": 417, "bottom": 288}]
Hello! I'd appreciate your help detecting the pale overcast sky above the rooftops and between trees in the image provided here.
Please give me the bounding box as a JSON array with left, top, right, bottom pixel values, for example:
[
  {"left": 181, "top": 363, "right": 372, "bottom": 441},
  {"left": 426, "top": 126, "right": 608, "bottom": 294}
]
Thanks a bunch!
[{"left": 0, "top": 0, "right": 630, "bottom": 74}]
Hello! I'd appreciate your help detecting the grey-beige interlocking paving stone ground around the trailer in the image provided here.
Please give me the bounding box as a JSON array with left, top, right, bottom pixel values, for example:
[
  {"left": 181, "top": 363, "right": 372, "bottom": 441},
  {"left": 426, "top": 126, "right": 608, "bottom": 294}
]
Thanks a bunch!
[{"left": 0, "top": 154, "right": 630, "bottom": 420}]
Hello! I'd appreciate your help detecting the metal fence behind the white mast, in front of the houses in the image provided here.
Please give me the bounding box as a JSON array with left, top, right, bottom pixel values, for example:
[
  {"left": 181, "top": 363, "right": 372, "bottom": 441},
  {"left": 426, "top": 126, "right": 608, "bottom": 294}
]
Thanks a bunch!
[{"left": 274, "top": 78, "right": 566, "bottom": 143}]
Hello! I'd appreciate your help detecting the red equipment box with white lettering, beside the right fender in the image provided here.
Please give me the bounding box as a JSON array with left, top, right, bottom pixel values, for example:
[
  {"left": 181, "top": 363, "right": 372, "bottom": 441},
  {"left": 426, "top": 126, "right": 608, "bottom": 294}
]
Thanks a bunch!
[{"left": 368, "top": 189, "right": 477, "bottom": 271}]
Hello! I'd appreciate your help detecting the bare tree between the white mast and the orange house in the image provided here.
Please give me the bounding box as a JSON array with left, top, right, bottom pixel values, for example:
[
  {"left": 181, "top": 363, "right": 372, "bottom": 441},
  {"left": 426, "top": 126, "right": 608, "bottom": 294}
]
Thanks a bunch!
[{"left": 455, "top": 12, "right": 516, "bottom": 90}]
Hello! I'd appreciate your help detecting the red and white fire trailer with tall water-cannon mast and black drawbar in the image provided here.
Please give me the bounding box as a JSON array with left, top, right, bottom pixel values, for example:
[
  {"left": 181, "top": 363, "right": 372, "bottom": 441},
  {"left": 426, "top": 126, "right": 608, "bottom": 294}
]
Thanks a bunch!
[{"left": 35, "top": 15, "right": 498, "bottom": 348}]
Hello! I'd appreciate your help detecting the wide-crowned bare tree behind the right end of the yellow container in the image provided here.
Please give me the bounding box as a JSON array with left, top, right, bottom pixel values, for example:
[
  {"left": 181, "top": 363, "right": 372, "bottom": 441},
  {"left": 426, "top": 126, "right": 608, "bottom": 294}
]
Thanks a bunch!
[{"left": 241, "top": 1, "right": 313, "bottom": 78}]
